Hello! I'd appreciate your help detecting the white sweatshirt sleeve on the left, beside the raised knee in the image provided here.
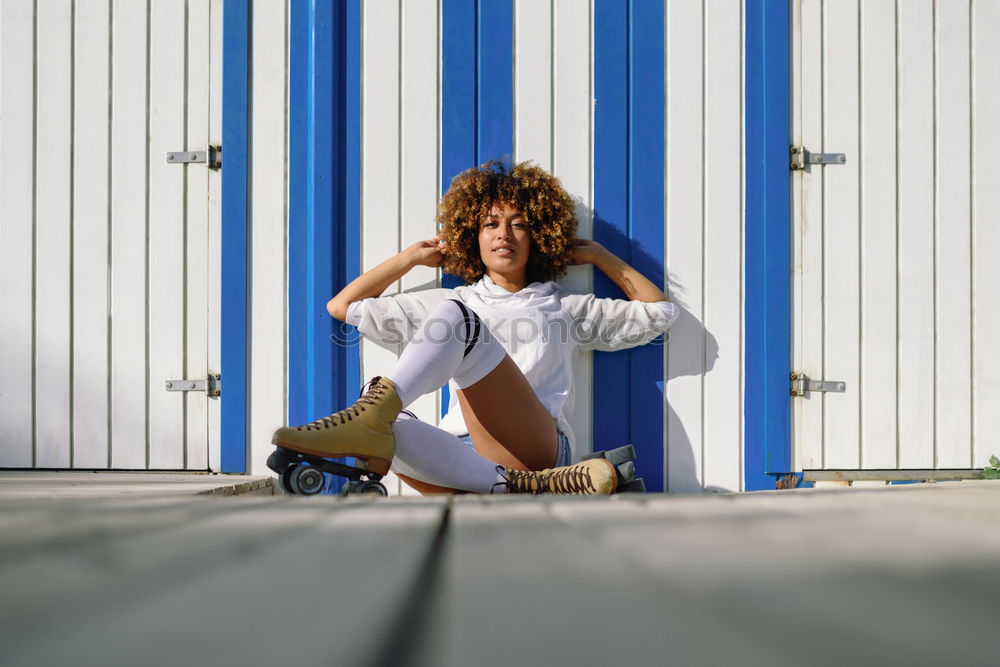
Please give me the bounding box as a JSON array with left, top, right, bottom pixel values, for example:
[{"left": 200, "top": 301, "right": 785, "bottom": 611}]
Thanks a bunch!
[{"left": 347, "top": 289, "right": 455, "bottom": 352}]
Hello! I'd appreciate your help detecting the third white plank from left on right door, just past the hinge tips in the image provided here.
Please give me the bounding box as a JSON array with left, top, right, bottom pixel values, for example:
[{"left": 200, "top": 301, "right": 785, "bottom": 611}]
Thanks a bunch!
[{"left": 858, "top": 0, "right": 897, "bottom": 468}]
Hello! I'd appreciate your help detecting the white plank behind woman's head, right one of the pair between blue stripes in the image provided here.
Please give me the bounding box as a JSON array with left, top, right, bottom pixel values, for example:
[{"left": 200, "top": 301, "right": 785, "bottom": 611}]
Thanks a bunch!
[{"left": 552, "top": 0, "right": 594, "bottom": 456}]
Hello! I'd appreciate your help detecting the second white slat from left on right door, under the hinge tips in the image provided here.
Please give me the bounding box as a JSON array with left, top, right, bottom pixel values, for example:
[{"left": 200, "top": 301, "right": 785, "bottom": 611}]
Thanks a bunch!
[{"left": 820, "top": 2, "right": 860, "bottom": 468}]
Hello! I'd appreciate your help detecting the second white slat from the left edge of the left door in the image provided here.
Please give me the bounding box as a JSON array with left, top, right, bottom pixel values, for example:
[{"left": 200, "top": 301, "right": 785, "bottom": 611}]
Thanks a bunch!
[{"left": 35, "top": 0, "right": 72, "bottom": 468}]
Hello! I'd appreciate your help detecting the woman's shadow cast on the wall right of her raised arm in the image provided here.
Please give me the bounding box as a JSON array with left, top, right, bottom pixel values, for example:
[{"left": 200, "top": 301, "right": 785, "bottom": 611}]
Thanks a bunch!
[{"left": 593, "top": 213, "right": 724, "bottom": 492}]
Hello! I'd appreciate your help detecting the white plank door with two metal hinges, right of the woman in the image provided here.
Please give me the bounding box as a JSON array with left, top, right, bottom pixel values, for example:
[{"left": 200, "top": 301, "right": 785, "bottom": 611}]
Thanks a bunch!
[{"left": 792, "top": 0, "right": 1000, "bottom": 470}]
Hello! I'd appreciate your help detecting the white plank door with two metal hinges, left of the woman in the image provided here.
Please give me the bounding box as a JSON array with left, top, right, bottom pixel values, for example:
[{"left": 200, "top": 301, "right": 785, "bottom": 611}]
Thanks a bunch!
[{"left": 0, "top": 0, "right": 222, "bottom": 470}]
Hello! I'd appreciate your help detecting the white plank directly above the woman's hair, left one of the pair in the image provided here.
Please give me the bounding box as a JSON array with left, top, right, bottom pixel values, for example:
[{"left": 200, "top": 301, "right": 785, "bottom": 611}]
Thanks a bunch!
[{"left": 514, "top": 0, "right": 556, "bottom": 171}]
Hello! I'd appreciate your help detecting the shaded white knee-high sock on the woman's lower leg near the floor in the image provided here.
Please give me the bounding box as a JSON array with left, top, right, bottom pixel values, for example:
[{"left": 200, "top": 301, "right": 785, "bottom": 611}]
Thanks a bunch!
[{"left": 392, "top": 414, "right": 506, "bottom": 493}]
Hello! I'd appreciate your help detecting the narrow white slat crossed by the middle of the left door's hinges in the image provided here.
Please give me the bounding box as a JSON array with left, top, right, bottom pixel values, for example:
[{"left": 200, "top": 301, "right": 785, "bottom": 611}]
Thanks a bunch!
[{"left": 184, "top": 2, "right": 217, "bottom": 470}]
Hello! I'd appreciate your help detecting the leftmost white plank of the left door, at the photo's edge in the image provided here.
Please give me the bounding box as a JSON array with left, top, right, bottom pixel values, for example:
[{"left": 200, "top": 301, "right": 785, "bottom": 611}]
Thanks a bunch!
[{"left": 0, "top": 0, "right": 35, "bottom": 468}]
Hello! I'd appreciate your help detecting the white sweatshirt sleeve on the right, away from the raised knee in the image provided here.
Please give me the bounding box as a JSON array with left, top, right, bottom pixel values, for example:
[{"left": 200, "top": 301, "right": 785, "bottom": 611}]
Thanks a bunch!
[{"left": 561, "top": 294, "right": 679, "bottom": 352}]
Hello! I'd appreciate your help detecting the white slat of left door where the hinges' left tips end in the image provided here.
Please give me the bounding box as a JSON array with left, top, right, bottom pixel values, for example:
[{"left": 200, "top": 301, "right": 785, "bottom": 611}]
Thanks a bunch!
[{"left": 147, "top": 2, "right": 188, "bottom": 469}]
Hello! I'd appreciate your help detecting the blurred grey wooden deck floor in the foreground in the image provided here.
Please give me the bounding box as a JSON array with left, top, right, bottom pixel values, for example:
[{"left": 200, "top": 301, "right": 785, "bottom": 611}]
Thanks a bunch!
[{"left": 0, "top": 482, "right": 1000, "bottom": 666}]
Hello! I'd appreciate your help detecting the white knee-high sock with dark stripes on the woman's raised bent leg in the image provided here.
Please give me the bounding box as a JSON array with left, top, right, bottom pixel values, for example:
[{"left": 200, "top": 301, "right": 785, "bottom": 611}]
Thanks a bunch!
[{"left": 389, "top": 300, "right": 507, "bottom": 408}]
